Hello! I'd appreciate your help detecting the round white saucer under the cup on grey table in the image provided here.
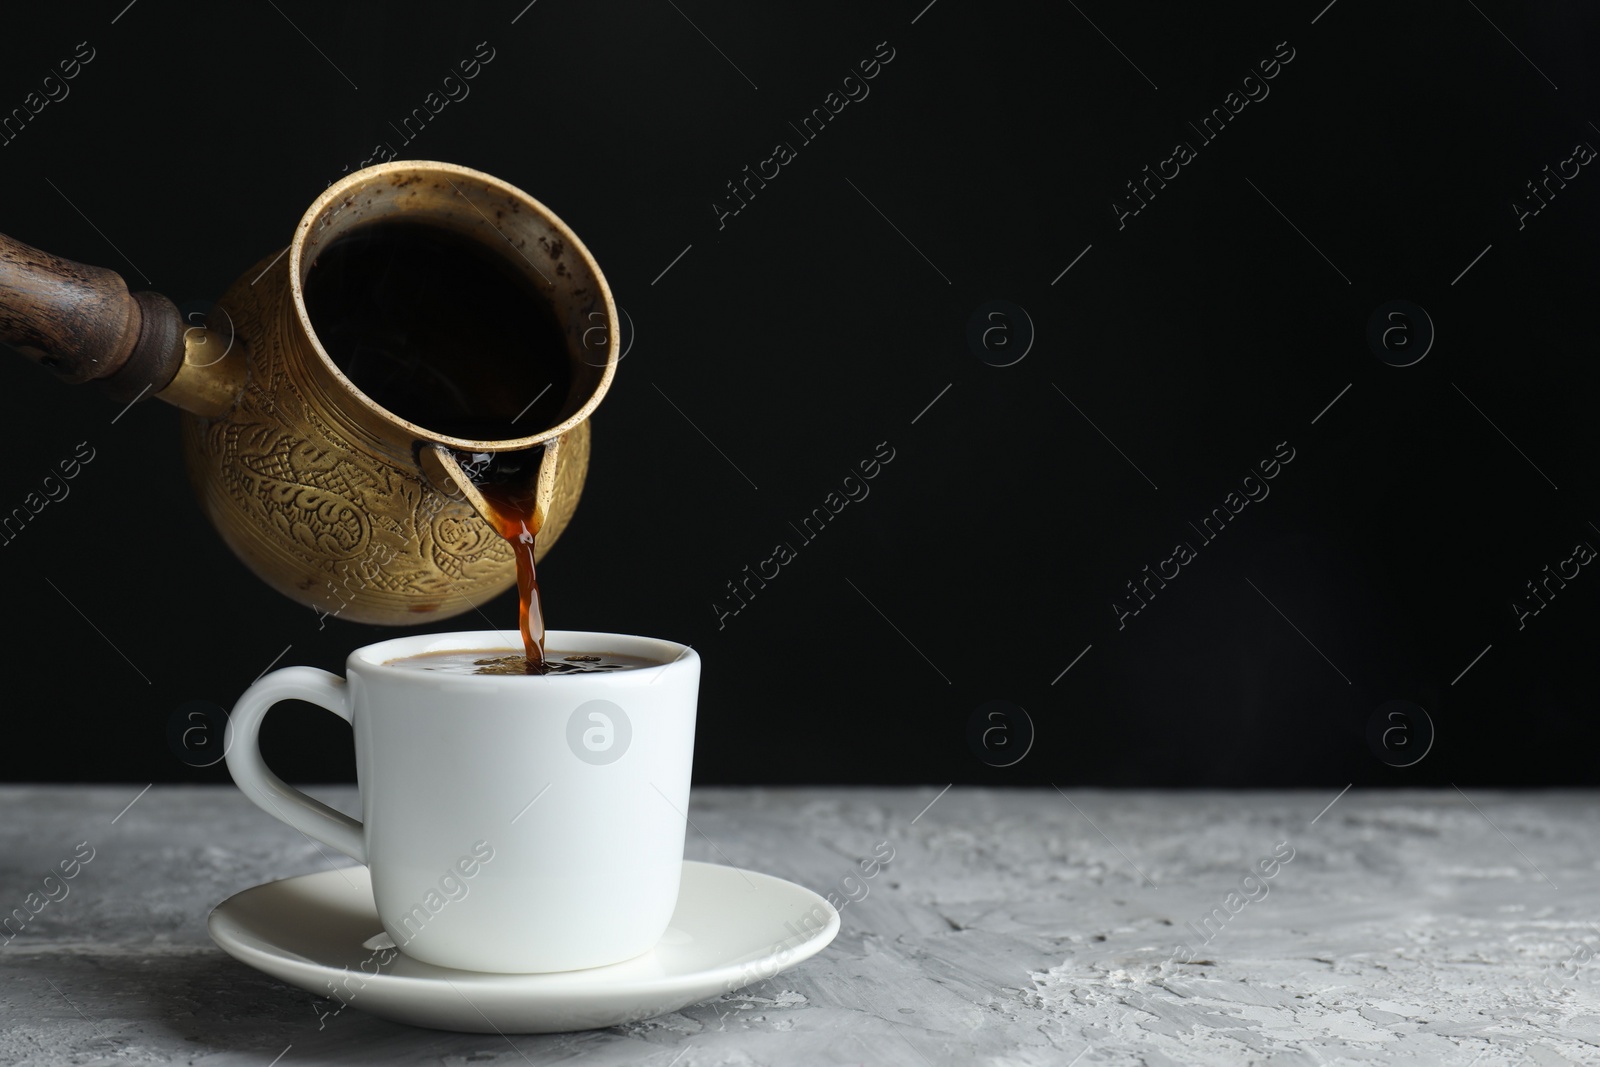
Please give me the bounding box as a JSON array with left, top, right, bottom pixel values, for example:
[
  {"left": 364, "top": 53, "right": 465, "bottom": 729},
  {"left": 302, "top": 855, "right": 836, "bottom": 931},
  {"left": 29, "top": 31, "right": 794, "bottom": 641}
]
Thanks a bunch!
[{"left": 206, "top": 861, "right": 838, "bottom": 1033}]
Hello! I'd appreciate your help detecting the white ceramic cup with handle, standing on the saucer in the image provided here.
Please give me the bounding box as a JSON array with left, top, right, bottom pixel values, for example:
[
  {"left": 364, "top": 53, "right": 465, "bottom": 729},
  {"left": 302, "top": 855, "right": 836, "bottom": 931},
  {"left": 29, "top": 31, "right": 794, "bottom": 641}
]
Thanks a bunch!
[{"left": 226, "top": 630, "right": 699, "bottom": 973}]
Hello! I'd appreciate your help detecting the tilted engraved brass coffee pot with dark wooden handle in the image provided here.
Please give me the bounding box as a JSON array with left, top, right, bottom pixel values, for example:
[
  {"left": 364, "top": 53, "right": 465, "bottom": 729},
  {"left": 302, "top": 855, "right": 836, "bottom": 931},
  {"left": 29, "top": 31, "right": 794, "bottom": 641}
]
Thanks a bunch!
[{"left": 0, "top": 162, "right": 619, "bottom": 625}]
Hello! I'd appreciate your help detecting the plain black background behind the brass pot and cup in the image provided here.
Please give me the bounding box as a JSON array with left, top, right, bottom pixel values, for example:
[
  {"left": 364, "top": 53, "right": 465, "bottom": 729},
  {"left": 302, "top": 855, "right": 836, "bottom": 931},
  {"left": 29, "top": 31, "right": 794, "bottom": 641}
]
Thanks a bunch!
[{"left": 0, "top": 0, "right": 1600, "bottom": 787}]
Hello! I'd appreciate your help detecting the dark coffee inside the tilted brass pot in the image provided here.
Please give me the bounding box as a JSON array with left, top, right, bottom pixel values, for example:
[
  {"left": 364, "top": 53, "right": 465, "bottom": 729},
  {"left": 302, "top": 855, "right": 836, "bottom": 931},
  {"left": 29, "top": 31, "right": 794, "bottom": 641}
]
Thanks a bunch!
[{"left": 304, "top": 222, "right": 571, "bottom": 442}]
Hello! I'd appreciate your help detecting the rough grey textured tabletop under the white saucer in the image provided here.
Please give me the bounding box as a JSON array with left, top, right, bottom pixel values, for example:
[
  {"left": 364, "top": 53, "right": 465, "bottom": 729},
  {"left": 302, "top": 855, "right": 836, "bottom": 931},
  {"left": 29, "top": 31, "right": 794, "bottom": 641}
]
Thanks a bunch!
[{"left": 0, "top": 787, "right": 1600, "bottom": 1067}]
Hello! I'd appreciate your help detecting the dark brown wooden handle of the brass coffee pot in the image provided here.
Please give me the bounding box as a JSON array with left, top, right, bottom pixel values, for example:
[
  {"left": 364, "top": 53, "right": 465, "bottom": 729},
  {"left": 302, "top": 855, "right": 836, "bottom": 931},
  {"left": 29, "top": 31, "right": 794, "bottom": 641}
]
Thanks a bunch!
[{"left": 0, "top": 234, "right": 184, "bottom": 400}]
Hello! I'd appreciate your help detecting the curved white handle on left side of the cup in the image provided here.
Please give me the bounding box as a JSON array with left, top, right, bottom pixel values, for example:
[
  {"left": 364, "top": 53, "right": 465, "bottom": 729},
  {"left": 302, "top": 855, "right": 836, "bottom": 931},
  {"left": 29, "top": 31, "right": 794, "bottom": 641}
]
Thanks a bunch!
[{"left": 222, "top": 667, "right": 366, "bottom": 864}]
